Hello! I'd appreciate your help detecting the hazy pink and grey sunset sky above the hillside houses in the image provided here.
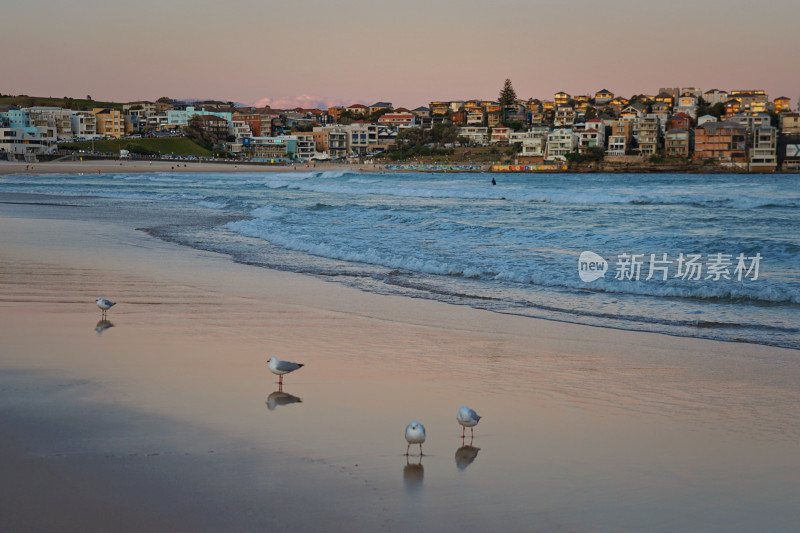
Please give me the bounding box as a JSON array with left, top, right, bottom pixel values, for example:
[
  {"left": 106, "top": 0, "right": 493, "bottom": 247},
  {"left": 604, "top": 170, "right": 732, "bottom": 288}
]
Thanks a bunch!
[{"left": 0, "top": 0, "right": 800, "bottom": 108}]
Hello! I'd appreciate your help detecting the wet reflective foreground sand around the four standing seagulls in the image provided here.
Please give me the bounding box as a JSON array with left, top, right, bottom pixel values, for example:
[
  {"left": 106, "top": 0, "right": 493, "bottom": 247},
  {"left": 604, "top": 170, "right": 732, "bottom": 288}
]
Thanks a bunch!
[{"left": 0, "top": 195, "right": 800, "bottom": 532}]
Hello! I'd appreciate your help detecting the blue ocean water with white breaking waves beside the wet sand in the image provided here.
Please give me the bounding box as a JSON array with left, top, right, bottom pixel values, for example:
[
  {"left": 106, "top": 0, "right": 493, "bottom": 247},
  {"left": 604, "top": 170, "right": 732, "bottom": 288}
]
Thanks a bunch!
[{"left": 0, "top": 170, "right": 800, "bottom": 349}]
